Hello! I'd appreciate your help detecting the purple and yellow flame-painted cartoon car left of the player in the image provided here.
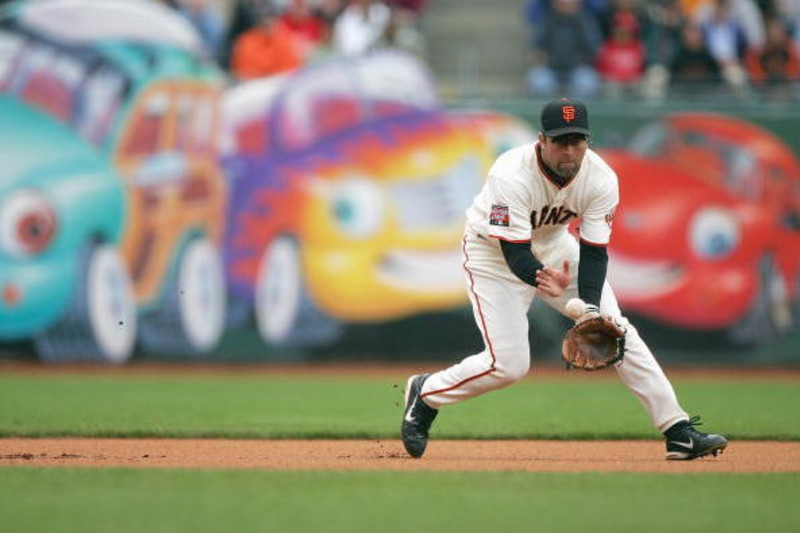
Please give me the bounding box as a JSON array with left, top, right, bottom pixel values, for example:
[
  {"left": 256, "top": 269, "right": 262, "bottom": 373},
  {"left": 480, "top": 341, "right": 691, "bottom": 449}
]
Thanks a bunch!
[{"left": 224, "top": 52, "right": 533, "bottom": 346}]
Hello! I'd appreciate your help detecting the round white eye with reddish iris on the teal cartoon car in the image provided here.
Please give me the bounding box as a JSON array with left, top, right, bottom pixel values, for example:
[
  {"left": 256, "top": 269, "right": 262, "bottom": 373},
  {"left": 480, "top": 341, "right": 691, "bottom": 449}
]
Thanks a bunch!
[{"left": 0, "top": 190, "right": 56, "bottom": 257}]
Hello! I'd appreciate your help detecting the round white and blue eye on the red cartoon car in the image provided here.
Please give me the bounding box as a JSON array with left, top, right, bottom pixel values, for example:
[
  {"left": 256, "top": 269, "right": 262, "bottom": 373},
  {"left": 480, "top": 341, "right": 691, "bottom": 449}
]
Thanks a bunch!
[{"left": 689, "top": 207, "right": 741, "bottom": 259}]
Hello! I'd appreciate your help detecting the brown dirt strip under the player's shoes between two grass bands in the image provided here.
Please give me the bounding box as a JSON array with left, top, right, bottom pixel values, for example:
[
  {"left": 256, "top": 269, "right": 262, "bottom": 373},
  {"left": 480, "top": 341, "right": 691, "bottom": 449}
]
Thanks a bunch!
[{"left": 0, "top": 439, "right": 800, "bottom": 473}]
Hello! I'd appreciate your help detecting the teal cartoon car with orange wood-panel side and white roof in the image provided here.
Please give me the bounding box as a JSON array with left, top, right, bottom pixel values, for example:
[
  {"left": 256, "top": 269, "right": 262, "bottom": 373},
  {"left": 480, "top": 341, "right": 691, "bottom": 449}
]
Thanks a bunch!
[{"left": 0, "top": 0, "right": 227, "bottom": 362}]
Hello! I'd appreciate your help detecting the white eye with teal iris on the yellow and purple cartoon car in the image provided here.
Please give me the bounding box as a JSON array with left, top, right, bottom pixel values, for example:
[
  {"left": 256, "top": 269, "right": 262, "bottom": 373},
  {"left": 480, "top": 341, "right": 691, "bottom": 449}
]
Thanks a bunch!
[{"left": 331, "top": 178, "right": 384, "bottom": 238}]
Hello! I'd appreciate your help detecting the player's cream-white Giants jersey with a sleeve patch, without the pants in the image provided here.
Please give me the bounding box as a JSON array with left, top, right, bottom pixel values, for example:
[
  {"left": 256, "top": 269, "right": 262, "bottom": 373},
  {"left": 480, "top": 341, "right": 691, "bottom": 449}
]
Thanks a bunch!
[{"left": 467, "top": 143, "right": 619, "bottom": 262}]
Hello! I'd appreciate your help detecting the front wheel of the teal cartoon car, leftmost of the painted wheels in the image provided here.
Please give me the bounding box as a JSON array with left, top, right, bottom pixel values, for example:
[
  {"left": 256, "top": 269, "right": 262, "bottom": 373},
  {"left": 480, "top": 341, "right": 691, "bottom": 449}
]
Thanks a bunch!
[{"left": 34, "top": 244, "right": 136, "bottom": 363}]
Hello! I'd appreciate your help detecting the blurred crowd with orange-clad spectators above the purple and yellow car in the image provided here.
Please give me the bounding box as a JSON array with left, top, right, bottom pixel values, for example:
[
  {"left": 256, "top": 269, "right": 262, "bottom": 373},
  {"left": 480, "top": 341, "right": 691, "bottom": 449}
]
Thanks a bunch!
[{"left": 155, "top": 0, "right": 426, "bottom": 80}]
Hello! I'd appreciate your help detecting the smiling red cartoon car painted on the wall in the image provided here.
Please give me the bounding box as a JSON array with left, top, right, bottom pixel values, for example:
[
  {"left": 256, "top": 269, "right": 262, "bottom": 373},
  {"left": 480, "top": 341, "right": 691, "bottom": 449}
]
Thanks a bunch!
[{"left": 604, "top": 113, "right": 800, "bottom": 343}]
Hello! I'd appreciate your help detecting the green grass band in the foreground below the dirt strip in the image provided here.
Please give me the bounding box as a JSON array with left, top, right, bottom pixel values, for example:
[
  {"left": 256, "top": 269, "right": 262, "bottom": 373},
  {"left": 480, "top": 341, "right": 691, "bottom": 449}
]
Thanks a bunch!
[{"left": 0, "top": 467, "right": 800, "bottom": 533}]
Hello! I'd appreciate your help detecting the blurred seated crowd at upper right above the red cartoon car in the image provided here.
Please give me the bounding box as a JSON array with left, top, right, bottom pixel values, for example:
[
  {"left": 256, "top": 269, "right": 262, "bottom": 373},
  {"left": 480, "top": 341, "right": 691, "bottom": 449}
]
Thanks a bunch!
[{"left": 525, "top": 0, "right": 800, "bottom": 101}]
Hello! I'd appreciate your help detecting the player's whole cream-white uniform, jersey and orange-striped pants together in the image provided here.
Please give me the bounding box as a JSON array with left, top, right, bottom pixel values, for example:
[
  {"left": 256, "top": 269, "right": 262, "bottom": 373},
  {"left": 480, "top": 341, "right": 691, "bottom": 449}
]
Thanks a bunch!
[{"left": 421, "top": 140, "right": 688, "bottom": 431}]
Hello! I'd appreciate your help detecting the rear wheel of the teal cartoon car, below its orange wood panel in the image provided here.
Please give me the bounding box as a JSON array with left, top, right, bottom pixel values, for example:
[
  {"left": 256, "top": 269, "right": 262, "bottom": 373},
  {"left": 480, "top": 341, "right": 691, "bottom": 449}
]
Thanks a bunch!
[{"left": 140, "top": 238, "right": 227, "bottom": 355}]
